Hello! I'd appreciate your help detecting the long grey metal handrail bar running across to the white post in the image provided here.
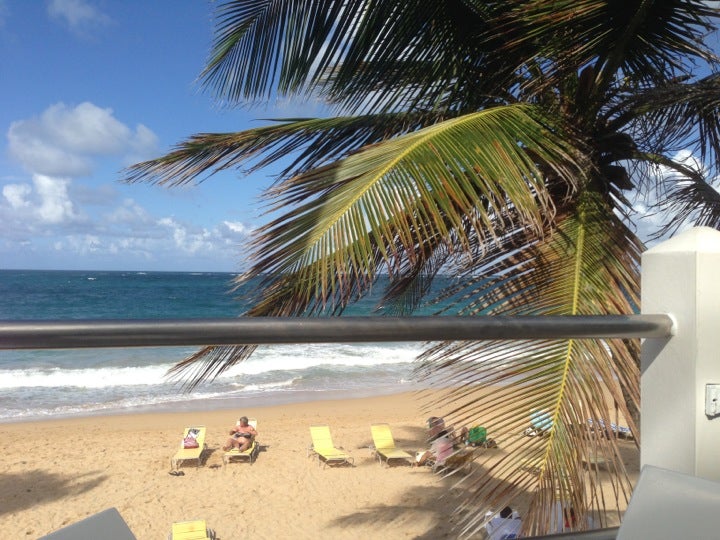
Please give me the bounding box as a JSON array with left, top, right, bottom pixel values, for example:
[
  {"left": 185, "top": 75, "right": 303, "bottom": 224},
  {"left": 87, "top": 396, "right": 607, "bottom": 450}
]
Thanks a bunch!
[{"left": 0, "top": 315, "right": 672, "bottom": 349}]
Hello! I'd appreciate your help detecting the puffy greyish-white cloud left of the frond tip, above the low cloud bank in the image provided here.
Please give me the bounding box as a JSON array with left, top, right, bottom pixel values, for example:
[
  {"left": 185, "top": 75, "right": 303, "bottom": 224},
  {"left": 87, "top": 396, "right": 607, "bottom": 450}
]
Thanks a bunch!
[{"left": 7, "top": 102, "right": 157, "bottom": 178}]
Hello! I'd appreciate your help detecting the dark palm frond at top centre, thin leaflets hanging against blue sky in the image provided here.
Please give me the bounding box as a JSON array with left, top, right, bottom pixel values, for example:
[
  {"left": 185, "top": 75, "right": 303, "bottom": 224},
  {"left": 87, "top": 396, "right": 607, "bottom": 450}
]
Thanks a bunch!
[{"left": 201, "top": 0, "right": 528, "bottom": 114}]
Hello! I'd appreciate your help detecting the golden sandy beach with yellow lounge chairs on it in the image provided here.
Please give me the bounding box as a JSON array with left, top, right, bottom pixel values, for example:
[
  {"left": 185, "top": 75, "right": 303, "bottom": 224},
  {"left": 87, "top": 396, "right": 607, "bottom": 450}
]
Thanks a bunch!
[{"left": 0, "top": 394, "right": 638, "bottom": 540}]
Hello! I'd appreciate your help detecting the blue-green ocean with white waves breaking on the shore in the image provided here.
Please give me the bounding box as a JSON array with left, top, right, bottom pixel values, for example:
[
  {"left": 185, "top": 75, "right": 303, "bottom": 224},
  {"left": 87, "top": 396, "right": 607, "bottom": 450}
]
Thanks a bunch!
[{"left": 0, "top": 270, "right": 437, "bottom": 422}]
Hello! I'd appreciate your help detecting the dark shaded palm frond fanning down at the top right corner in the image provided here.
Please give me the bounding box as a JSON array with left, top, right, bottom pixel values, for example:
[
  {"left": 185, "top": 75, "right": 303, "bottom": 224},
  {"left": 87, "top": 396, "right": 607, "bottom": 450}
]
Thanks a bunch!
[{"left": 495, "top": 0, "right": 719, "bottom": 96}]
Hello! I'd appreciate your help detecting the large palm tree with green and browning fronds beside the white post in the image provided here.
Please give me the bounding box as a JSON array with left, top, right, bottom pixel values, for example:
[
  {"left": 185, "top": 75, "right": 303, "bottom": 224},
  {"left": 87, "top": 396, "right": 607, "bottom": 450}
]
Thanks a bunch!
[{"left": 125, "top": 0, "right": 720, "bottom": 534}]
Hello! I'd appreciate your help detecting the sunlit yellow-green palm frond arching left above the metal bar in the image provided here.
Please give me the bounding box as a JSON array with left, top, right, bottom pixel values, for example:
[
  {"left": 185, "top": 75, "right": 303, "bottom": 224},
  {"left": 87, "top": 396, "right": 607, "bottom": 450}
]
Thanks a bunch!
[{"left": 248, "top": 105, "right": 577, "bottom": 302}]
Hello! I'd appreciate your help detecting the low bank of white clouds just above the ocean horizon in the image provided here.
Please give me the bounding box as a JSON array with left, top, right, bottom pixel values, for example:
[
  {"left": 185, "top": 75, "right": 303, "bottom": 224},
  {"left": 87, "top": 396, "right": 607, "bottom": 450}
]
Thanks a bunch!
[{"left": 0, "top": 180, "right": 252, "bottom": 271}]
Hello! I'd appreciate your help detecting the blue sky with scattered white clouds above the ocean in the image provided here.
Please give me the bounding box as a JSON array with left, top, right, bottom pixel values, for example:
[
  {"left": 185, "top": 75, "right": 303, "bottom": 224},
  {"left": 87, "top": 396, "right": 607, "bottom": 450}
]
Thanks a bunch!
[{"left": 0, "top": 0, "right": 717, "bottom": 272}]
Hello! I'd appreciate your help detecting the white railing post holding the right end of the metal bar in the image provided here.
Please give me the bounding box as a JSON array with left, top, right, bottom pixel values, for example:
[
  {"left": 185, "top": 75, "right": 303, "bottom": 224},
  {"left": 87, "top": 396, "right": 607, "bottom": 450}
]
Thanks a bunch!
[{"left": 640, "top": 227, "right": 720, "bottom": 480}]
